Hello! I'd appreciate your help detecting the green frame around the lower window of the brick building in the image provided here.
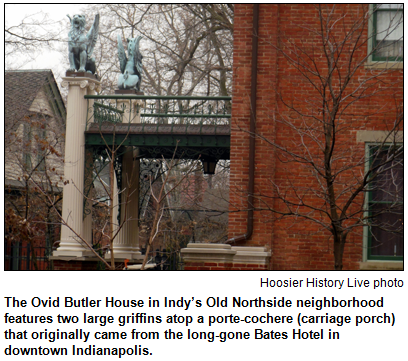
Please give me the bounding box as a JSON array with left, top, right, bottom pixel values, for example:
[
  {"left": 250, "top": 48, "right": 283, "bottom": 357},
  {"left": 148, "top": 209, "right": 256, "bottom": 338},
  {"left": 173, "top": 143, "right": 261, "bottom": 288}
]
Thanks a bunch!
[{"left": 363, "top": 142, "right": 404, "bottom": 262}]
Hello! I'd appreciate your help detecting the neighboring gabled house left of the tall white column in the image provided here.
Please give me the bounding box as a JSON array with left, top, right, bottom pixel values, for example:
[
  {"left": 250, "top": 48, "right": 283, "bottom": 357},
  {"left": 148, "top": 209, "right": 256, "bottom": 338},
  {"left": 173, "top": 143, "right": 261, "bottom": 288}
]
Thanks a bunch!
[{"left": 5, "top": 70, "right": 66, "bottom": 270}]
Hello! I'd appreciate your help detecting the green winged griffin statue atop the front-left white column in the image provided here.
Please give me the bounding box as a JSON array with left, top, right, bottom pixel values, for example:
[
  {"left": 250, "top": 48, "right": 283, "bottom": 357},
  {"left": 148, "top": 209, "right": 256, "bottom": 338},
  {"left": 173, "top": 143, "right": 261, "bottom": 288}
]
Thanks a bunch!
[{"left": 67, "top": 14, "right": 99, "bottom": 74}]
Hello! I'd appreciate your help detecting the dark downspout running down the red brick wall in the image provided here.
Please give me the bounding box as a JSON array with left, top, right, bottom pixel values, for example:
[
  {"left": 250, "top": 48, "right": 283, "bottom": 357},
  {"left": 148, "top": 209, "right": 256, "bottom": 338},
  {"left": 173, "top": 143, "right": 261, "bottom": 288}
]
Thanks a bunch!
[{"left": 227, "top": 4, "right": 259, "bottom": 243}]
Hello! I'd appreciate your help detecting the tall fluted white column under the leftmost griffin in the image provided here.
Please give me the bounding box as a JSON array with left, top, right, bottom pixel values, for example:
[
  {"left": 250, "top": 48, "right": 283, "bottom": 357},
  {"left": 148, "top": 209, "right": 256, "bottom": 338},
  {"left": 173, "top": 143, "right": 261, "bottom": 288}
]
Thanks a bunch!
[{"left": 53, "top": 77, "right": 100, "bottom": 257}]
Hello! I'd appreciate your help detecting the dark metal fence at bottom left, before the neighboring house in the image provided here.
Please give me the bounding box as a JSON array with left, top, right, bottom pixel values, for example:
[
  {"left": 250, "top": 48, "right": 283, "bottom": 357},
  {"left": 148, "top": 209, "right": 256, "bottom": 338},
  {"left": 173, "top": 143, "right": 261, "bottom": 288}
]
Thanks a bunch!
[{"left": 4, "top": 242, "right": 52, "bottom": 271}]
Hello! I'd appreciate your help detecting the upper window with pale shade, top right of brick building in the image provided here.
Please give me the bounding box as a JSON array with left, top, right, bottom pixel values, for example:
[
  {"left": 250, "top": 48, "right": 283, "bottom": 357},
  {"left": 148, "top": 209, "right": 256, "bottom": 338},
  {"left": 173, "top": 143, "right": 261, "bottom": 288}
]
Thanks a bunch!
[{"left": 372, "top": 4, "right": 404, "bottom": 61}]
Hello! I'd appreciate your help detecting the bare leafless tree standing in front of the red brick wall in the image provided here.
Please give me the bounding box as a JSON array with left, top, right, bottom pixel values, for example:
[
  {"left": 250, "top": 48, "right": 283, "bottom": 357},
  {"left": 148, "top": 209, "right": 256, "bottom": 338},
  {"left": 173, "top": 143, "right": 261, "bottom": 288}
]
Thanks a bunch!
[{"left": 233, "top": 5, "right": 403, "bottom": 270}]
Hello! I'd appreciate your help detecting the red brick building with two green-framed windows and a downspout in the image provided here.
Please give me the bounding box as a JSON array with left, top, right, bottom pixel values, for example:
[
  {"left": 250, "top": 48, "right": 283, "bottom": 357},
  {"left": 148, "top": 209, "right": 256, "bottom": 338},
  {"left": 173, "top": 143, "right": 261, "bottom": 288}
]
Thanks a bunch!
[{"left": 229, "top": 4, "right": 403, "bottom": 270}]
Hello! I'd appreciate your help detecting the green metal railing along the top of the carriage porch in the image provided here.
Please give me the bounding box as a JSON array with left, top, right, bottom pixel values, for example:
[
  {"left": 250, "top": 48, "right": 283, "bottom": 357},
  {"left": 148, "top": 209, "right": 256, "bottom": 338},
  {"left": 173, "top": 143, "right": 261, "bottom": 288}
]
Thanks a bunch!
[{"left": 85, "top": 95, "right": 231, "bottom": 130}]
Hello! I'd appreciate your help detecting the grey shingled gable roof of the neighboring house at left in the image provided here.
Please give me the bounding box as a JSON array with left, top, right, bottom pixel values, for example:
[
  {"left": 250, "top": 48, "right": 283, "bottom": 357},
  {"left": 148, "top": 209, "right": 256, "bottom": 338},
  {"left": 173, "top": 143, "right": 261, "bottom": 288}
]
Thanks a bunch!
[{"left": 4, "top": 69, "right": 66, "bottom": 125}]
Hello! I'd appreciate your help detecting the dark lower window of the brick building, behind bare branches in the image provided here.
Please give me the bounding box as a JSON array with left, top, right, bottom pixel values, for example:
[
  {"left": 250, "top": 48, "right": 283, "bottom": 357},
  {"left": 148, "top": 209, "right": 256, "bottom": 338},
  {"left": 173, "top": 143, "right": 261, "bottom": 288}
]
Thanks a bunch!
[{"left": 367, "top": 146, "right": 404, "bottom": 260}]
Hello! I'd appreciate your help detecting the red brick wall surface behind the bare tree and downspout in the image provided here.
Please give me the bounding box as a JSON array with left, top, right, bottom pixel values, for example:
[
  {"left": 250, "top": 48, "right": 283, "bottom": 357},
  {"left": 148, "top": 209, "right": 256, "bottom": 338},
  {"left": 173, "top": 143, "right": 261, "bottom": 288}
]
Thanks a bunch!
[{"left": 229, "top": 4, "right": 403, "bottom": 270}]
